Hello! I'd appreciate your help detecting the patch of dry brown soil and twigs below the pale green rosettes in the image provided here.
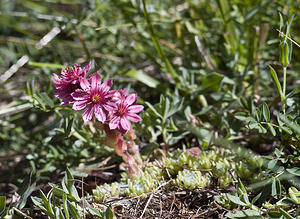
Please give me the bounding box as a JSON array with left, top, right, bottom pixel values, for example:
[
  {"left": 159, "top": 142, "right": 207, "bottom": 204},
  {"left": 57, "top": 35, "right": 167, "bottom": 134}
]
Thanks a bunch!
[{"left": 95, "top": 187, "right": 227, "bottom": 219}]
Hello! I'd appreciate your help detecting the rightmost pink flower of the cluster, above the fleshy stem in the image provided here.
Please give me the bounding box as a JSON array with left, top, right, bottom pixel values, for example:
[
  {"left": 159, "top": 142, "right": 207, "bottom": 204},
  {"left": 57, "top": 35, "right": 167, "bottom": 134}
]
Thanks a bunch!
[{"left": 109, "top": 90, "right": 144, "bottom": 133}]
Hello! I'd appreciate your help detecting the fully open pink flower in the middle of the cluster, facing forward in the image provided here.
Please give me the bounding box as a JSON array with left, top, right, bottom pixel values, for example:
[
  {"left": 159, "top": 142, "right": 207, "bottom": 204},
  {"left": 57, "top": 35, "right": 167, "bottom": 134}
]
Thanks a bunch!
[{"left": 72, "top": 73, "right": 117, "bottom": 123}]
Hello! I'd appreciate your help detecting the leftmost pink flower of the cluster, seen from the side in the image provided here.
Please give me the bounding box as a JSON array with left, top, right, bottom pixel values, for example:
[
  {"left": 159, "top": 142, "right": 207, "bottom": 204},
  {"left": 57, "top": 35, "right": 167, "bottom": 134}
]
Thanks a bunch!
[{"left": 52, "top": 62, "right": 92, "bottom": 105}]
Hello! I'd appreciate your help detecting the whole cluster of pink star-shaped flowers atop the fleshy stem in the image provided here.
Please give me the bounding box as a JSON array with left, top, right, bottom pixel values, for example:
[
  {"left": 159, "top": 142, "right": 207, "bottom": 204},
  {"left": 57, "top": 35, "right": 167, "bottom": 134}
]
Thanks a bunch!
[{"left": 53, "top": 62, "right": 144, "bottom": 133}]
